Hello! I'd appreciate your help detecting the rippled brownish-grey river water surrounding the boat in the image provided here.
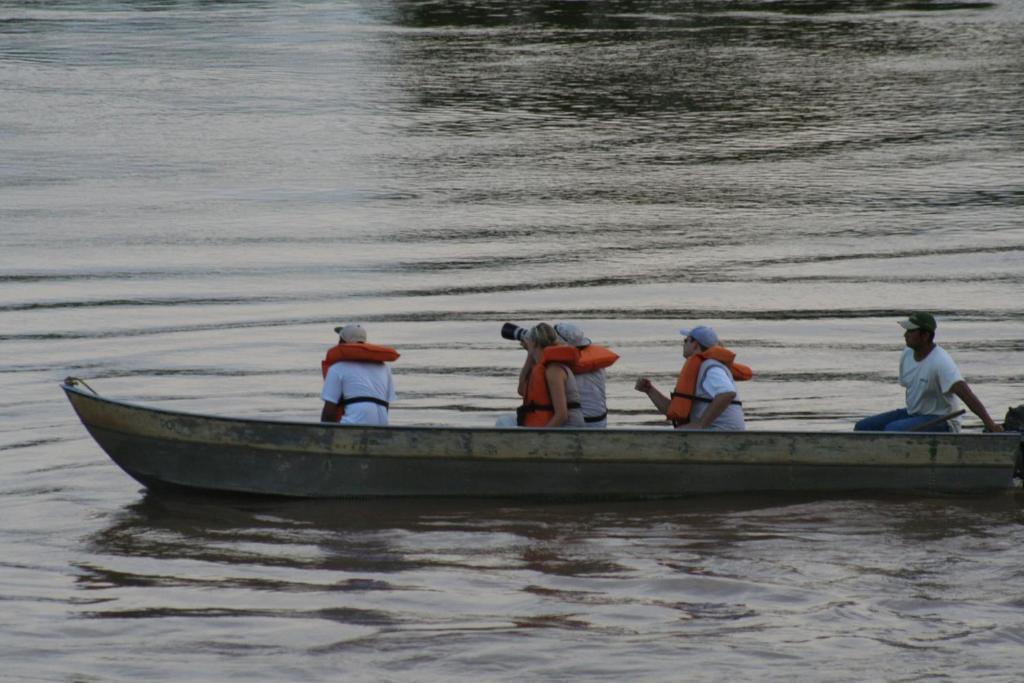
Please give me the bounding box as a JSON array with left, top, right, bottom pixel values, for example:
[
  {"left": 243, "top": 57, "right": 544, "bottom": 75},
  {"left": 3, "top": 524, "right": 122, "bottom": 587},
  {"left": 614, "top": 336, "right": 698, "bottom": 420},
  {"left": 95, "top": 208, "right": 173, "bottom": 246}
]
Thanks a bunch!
[{"left": 0, "top": 0, "right": 1024, "bottom": 682}]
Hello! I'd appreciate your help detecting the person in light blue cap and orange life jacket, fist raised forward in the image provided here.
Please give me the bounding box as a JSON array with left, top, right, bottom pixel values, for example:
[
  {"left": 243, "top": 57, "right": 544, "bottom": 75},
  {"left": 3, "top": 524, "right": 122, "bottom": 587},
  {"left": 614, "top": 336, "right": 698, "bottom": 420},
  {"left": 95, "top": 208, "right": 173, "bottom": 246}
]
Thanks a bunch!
[{"left": 635, "top": 326, "right": 754, "bottom": 431}]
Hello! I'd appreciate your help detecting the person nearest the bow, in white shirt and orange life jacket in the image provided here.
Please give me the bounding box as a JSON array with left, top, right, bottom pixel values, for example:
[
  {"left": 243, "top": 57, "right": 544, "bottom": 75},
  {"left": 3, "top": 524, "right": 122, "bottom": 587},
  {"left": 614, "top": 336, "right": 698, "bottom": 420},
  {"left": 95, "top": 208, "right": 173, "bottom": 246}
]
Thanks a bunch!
[{"left": 321, "top": 325, "right": 398, "bottom": 425}]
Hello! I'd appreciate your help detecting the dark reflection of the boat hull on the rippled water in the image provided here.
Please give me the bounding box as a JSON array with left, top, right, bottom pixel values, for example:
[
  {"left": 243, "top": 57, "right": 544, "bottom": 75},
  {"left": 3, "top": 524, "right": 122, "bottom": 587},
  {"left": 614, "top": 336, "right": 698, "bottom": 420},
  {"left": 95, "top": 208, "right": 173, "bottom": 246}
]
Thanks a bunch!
[{"left": 81, "top": 490, "right": 1024, "bottom": 590}]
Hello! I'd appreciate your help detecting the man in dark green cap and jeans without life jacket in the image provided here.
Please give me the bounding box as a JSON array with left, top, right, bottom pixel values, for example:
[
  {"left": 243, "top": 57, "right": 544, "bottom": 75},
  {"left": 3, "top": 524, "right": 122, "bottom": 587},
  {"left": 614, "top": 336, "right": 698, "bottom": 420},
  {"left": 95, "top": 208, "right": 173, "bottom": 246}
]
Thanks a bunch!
[{"left": 853, "top": 312, "right": 1002, "bottom": 432}]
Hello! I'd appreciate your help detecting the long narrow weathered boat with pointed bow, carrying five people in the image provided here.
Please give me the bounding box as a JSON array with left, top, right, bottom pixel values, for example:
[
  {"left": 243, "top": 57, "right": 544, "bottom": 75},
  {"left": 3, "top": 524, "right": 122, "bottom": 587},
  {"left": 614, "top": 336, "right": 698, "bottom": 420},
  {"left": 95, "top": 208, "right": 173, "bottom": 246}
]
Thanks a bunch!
[{"left": 62, "top": 378, "right": 1020, "bottom": 498}]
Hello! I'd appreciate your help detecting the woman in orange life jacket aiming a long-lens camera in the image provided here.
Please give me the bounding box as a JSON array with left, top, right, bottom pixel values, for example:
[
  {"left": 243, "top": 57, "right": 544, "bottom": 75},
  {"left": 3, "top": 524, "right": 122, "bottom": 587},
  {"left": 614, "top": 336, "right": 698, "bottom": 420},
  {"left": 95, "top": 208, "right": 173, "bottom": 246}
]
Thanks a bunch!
[{"left": 498, "top": 323, "right": 586, "bottom": 428}]
